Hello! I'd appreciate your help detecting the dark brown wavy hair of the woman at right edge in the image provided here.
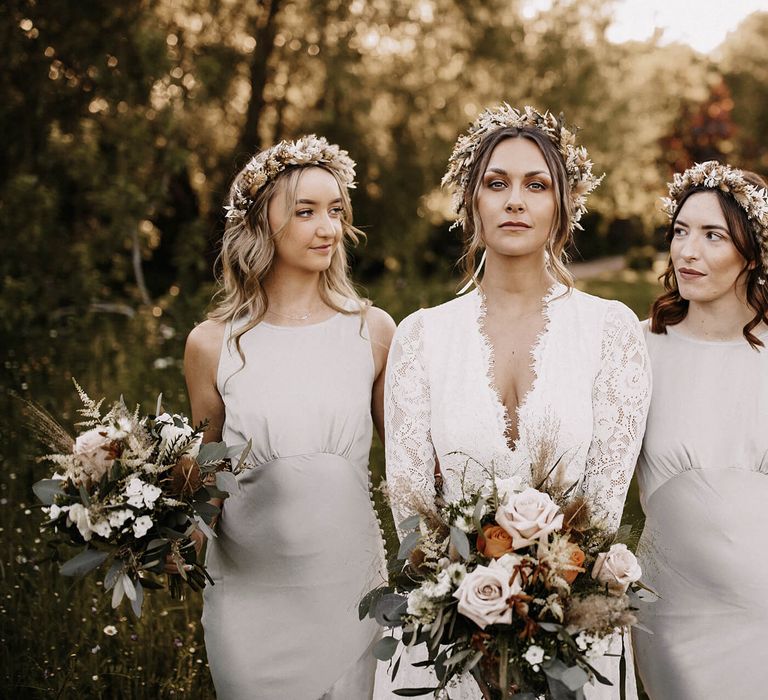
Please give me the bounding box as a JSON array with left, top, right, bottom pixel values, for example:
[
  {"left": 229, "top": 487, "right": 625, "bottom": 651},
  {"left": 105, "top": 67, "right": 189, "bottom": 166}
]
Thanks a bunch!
[{"left": 650, "top": 171, "right": 768, "bottom": 349}]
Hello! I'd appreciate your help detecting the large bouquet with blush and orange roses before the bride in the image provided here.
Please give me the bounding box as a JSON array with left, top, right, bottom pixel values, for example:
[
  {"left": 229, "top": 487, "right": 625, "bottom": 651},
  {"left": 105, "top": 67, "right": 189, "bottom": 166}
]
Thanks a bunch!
[{"left": 360, "top": 462, "right": 641, "bottom": 700}]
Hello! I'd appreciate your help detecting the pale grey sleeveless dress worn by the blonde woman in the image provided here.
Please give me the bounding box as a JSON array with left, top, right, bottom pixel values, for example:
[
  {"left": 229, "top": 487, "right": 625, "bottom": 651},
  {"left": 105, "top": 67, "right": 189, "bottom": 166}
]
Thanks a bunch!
[{"left": 202, "top": 313, "right": 384, "bottom": 700}]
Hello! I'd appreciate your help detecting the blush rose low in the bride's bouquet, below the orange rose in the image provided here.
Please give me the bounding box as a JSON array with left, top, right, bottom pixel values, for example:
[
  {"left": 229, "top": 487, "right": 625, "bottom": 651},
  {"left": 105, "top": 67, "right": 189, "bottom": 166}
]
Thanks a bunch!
[{"left": 453, "top": 561, "right": 520, "bottom": 629}]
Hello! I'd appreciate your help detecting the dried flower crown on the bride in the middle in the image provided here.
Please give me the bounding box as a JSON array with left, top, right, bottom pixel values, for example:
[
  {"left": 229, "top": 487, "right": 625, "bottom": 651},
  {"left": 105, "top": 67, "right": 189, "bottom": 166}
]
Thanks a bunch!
[{"left": 442, "top": 102, "right": 605, "bottom": 232}]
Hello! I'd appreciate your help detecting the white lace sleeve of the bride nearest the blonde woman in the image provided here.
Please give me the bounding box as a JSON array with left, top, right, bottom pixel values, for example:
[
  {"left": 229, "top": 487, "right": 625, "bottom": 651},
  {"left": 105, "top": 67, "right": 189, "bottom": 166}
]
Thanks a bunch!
[{"left": 384, "top": 312, "right": 435, "bottom": 536}]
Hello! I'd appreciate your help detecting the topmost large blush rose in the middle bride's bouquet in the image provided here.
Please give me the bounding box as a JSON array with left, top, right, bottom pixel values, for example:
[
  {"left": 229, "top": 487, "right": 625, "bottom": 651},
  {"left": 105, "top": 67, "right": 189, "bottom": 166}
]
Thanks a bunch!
[{"left": 496, "top": 487, "right": 563, "bottom": 549}]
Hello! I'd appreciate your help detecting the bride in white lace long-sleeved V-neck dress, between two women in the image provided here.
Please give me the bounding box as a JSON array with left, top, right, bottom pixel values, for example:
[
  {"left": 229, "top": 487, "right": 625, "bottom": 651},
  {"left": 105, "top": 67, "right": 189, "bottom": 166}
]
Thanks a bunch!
[{"left": 375, "top": 104, "right": 650, "bottom": 700}]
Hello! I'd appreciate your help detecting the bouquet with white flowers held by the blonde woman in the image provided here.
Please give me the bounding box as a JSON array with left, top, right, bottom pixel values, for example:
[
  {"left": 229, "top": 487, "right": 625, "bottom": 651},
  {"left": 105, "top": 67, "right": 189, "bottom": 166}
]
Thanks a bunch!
[{"left": 28, "top": 383, "right": 250, "bottom": 616}]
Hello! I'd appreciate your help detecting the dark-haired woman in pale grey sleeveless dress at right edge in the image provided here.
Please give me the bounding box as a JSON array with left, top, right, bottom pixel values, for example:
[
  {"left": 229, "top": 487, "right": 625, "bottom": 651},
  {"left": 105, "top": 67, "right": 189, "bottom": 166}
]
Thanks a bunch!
[{"left": 634, "top": 161, "right": 768, "bottom": 700}]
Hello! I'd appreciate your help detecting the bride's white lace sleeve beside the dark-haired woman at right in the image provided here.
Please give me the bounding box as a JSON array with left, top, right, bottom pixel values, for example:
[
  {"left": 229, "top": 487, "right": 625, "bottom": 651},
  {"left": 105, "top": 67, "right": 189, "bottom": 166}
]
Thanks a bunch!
[{"left": 585, "top": 304, "right": 651, "bottom": 530}]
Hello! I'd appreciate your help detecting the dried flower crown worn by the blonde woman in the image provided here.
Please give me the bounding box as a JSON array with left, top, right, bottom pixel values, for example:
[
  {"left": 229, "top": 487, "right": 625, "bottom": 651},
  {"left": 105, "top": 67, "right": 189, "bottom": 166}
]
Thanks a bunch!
[{"left": 224, "top": 134, "right": 355, "bottom": 223}]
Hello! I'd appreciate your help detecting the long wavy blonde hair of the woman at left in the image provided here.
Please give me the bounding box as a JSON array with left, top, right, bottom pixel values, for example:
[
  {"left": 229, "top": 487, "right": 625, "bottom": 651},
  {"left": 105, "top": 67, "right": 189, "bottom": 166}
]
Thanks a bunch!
[{"left": 208, "top": 163, "right": 370, "bottom": 365}]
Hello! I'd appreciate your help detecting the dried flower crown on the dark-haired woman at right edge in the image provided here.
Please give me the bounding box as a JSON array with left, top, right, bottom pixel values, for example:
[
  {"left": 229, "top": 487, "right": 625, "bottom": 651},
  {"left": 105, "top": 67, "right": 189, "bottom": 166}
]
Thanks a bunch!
[{"left": 661, "top": 160, "right": 768, "bottom": 271}]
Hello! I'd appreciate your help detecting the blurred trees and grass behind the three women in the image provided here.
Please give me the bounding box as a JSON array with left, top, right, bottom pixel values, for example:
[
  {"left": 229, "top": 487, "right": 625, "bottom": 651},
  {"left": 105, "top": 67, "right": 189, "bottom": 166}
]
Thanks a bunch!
[{"left": 0, "top": 0, "right": 768, "bottom": 698}]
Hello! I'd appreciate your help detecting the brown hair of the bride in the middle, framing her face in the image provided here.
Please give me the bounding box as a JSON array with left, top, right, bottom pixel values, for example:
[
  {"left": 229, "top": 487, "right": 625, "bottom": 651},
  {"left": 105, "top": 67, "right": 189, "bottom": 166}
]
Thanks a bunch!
[{"left": 459, "top": 127, "right": 573, "bottom": 288}]
